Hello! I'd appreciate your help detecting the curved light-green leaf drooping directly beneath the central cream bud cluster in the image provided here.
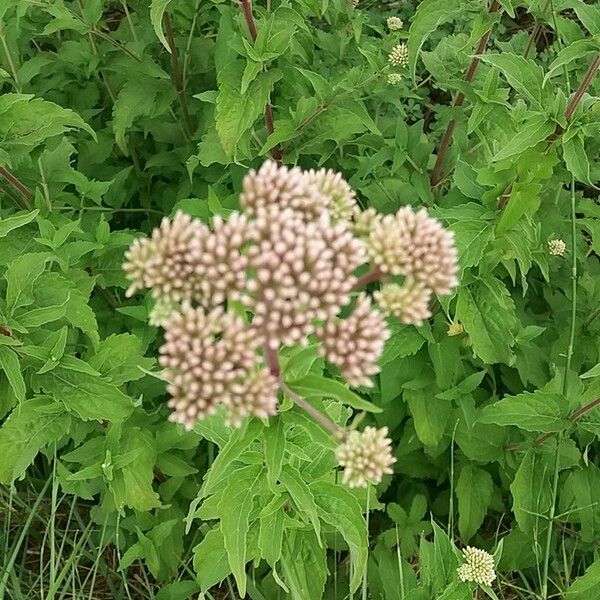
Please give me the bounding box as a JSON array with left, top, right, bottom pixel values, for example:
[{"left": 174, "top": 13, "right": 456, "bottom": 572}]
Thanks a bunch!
[{"left": 310, "top": 481, "right": 368, "bottom": 592}]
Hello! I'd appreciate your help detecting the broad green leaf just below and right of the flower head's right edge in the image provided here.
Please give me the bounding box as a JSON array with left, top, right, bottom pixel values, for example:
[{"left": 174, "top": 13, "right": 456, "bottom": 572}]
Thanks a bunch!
[{"left": 456, "top": 275, "right": 517, "bottom": 364}]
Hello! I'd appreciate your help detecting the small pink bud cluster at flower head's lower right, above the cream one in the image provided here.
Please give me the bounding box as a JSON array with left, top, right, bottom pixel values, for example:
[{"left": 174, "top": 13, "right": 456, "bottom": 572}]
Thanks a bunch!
[{"left": 317, "top": 294, "right": 390, "bottom": 387}]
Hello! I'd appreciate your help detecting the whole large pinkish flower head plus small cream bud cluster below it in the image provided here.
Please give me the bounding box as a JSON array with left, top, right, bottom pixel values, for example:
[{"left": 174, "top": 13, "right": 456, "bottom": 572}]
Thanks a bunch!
[{"left": 124, "top": 161, "right": 456, "bottom": 474}]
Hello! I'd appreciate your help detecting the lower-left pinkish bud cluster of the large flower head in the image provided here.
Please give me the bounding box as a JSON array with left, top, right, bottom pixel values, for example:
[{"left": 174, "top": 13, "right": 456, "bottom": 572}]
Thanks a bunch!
[{"left": 159, "top": 305, "right": 276, "bottom": 429}]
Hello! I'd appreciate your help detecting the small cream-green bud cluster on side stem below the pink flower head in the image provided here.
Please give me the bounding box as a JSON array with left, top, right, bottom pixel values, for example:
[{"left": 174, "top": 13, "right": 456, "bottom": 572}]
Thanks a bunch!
[{"left": 336, "top": 427, "right": 396, "bottom": 488}]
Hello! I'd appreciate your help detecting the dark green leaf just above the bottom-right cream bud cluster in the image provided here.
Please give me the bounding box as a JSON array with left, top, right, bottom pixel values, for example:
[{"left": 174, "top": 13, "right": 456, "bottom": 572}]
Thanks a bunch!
[{"left": 456, "top": 465, "right": 494, "bottom": 542}]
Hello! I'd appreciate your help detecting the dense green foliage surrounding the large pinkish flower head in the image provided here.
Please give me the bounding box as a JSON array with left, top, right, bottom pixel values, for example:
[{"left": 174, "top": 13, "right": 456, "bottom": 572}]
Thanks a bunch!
[{"left": 0, "top": 0, "right": 600, "bottom": 600}]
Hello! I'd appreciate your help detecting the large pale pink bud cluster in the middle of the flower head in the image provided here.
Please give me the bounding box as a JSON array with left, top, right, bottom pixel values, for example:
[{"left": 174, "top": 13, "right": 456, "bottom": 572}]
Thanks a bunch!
[{"left": 243, "top": 207, "right": 366, "bottom": 349}]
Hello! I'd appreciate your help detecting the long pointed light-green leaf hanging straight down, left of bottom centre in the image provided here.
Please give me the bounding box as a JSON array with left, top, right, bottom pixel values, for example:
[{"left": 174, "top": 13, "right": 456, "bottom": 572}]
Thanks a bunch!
[{"left": 219, "top": 470, "right": 262, "bottom": 598}]
